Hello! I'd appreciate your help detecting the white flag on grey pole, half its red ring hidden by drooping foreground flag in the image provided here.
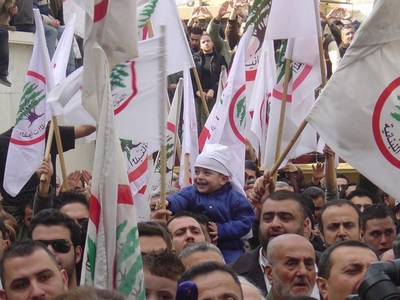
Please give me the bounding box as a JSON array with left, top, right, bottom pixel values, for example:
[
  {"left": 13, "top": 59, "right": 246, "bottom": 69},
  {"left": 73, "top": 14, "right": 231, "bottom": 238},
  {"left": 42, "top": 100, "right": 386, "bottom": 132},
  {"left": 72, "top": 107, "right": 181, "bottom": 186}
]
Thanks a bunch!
[{"left": 111, "top": 35, "right": 167, "bottom": 146}]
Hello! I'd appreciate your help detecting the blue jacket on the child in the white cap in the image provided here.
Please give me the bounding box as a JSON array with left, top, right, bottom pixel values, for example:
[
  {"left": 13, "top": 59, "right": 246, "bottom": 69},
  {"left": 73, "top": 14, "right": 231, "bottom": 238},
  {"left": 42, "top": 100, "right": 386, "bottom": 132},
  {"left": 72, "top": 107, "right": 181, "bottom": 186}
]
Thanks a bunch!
[{"left": 167, "top": 183, "right": 254, "bottom": 250}]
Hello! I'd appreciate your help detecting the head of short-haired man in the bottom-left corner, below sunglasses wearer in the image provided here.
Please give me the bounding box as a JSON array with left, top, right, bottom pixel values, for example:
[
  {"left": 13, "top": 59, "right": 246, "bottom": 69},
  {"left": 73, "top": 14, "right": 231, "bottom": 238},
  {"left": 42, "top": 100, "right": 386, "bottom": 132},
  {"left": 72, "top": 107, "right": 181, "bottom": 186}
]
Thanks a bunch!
[{"left": 0, "top": 240, "right": 68, "bottom": 300}]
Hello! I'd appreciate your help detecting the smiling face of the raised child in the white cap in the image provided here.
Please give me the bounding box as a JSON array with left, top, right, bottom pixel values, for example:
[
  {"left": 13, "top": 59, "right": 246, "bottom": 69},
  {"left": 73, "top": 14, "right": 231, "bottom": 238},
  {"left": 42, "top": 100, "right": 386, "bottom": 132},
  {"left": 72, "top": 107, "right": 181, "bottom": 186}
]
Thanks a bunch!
[{"left": 194, "top": 167, "right": 229, "bottom": 194}]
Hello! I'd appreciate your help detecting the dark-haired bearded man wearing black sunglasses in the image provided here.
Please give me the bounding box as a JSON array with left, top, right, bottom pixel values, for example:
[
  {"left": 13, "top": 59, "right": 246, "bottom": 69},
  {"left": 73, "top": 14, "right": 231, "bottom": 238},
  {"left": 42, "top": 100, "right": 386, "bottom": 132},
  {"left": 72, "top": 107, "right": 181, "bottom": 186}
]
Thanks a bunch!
[{"left": 29, "top": 209, "right": 82, "bottom": 289}]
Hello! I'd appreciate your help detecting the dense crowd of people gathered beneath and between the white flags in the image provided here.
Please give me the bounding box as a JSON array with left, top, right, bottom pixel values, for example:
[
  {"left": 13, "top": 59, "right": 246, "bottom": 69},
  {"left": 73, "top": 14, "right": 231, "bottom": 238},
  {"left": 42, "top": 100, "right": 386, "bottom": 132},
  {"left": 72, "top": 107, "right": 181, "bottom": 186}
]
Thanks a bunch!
[{"left": 0, "top": 0, "right": 400, "bottom": 300}]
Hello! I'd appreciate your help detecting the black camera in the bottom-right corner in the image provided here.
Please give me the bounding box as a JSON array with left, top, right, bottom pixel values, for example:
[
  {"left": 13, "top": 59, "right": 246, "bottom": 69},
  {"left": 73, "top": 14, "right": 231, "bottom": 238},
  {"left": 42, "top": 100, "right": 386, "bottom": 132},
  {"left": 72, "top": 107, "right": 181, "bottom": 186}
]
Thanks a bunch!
[{"left": 346, "top": 259, "right": 400, "bottom": 300}]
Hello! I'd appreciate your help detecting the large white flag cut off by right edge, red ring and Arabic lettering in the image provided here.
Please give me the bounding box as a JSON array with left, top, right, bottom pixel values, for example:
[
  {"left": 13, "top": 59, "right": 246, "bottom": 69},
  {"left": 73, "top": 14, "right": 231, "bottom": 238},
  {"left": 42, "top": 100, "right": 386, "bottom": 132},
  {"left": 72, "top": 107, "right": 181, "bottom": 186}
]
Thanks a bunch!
[{"left": 306, "top": 0, "right": 400, "bottom": 199}]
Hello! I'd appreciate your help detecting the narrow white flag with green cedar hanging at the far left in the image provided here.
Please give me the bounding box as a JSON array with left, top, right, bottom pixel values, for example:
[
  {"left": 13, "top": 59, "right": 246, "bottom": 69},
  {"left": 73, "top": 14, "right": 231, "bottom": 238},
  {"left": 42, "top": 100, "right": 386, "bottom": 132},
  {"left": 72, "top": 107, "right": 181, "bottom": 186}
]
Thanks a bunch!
[{"left": 3, "top": 9, "right": 54, "bottom": 197}]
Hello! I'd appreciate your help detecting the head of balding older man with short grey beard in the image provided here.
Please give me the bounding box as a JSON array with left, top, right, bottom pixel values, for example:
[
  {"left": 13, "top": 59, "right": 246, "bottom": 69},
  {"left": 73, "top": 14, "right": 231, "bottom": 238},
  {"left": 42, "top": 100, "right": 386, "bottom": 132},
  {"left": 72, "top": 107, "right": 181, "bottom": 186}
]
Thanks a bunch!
[{"left": 265, "top": 234, "right": 316, "bottom": 300}]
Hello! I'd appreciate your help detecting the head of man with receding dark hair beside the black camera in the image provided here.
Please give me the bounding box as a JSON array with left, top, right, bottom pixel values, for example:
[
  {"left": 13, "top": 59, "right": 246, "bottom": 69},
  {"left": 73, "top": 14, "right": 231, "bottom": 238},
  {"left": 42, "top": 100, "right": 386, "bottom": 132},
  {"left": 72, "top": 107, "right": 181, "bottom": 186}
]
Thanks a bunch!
[{"left": 317, "top": 240, "right": 378, "bottom": 300}]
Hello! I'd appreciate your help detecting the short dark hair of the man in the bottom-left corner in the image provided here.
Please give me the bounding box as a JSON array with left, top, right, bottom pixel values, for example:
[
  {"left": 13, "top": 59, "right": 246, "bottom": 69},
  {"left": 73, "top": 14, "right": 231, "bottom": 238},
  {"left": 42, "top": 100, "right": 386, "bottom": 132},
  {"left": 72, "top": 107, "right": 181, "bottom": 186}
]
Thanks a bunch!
[{"left": 0, "top": 239, "right": 58, "bottom": 288}]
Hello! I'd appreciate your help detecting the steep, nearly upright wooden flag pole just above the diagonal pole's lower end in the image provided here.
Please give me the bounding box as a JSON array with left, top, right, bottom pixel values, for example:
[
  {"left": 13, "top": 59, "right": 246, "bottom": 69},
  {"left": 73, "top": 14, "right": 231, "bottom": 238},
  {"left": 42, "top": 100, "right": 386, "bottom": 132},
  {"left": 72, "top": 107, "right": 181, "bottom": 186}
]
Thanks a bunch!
[{"left": 271, "top": 39, "right": 293, "bottom": 181}]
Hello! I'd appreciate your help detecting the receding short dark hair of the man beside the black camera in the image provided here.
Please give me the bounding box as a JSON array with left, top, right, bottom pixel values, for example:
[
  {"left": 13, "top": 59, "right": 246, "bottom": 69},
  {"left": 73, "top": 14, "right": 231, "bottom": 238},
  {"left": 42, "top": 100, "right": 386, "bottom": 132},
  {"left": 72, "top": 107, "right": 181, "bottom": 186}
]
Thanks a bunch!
[{"left": 318, "top": 240, "right": 379, "bottom": 279}]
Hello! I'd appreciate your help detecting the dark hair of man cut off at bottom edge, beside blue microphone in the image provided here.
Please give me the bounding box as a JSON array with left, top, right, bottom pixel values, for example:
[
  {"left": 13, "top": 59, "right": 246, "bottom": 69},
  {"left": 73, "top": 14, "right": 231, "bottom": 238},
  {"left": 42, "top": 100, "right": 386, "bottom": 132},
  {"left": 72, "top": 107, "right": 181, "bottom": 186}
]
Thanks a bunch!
[{"left": 178, "top": 261, "right": 243, "bottom": 298}]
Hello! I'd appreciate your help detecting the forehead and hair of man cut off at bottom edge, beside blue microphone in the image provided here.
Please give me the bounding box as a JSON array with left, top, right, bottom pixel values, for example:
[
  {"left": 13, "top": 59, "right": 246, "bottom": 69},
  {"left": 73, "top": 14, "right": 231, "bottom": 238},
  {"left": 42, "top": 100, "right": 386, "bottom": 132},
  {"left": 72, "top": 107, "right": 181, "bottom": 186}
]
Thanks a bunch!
[{"left": 178, "top": 261, "right": 244, "bottom": 300}]
